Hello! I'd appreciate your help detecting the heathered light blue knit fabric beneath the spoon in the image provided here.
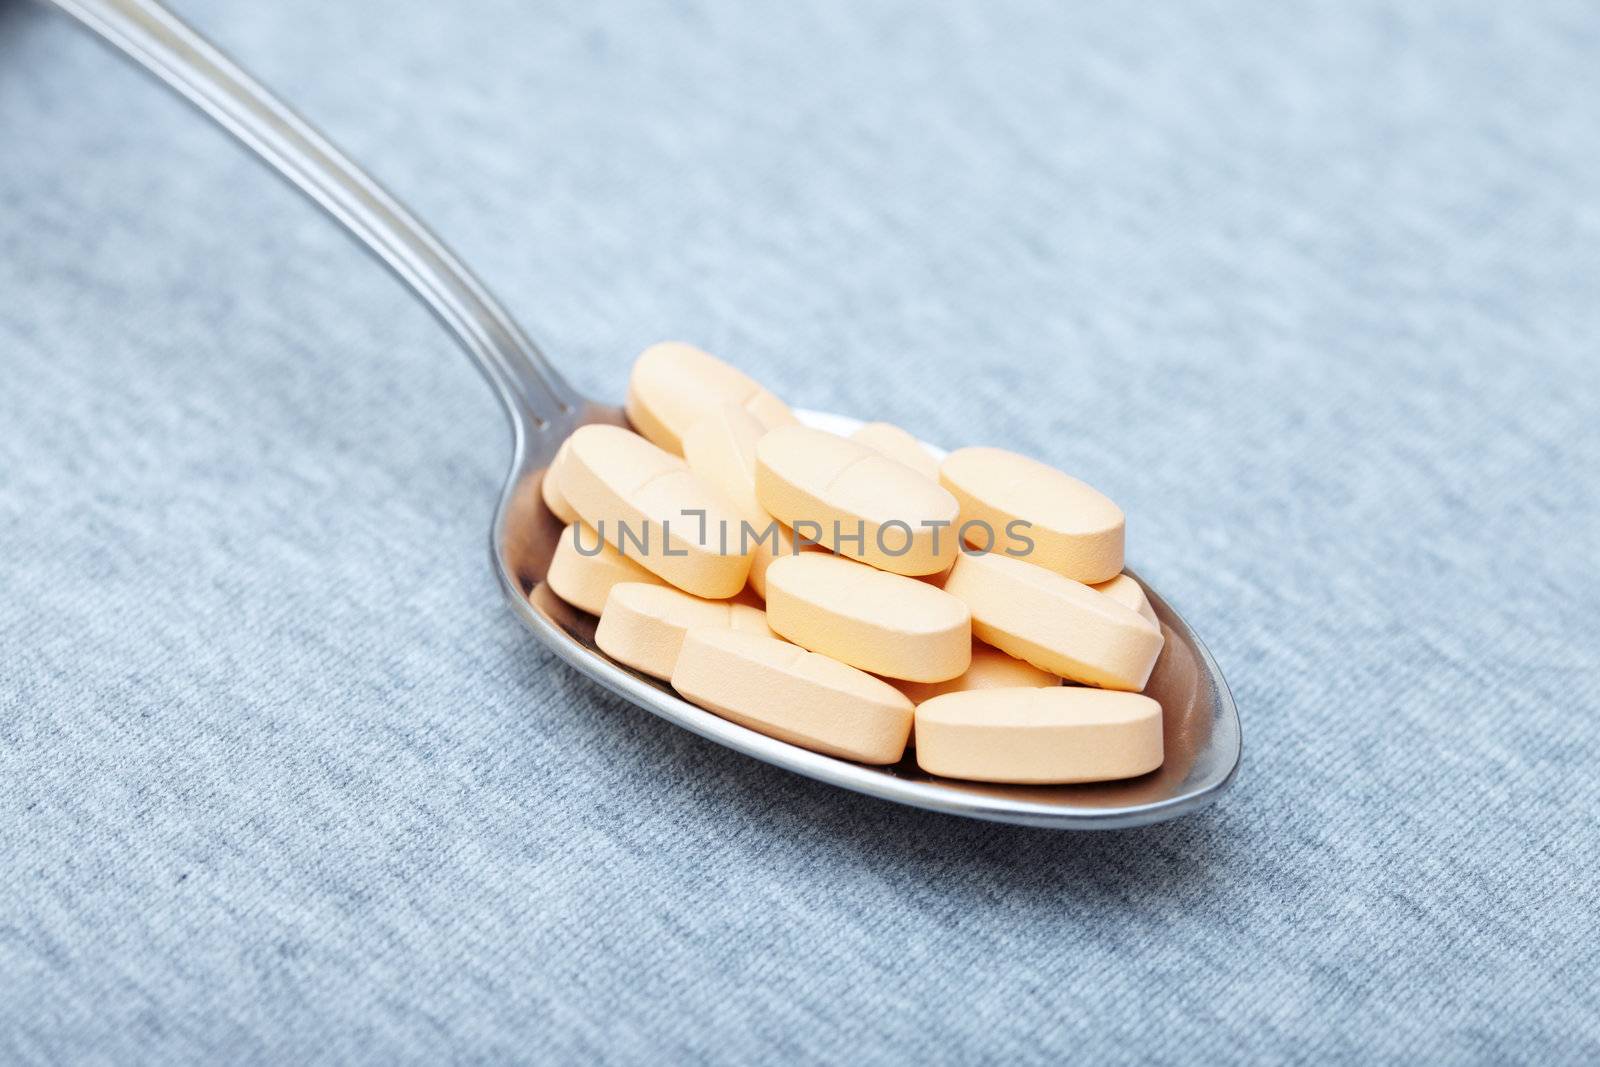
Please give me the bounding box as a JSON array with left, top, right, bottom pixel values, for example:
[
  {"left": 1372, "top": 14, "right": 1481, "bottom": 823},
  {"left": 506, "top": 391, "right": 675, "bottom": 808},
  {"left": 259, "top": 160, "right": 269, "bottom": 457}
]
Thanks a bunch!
[{"left": 0, "top": 0, "right": 1600, "bottom": 1062}]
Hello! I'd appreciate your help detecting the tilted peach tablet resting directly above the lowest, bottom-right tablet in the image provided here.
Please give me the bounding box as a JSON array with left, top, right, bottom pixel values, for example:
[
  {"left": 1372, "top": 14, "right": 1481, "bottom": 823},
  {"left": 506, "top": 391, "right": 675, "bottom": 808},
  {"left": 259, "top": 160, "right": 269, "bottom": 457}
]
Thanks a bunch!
[{"left": 944, "top": 552, "right": 1165, "bottom": 691}]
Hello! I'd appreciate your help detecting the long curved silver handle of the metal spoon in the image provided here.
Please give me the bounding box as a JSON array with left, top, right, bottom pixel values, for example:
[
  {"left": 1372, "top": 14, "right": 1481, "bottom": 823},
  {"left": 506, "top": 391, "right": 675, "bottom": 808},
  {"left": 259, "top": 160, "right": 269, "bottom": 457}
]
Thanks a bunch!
[{"left": 42, "top": 0, "right": 578, "bottom": 442}]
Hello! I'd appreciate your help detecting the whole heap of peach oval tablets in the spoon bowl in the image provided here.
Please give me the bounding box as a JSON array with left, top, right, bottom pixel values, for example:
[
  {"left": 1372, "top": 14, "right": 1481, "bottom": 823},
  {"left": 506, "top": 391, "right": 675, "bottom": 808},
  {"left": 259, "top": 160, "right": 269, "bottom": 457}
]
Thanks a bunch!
[{"left": 542, "top": 342, "right": 1163, "bottom": 784}]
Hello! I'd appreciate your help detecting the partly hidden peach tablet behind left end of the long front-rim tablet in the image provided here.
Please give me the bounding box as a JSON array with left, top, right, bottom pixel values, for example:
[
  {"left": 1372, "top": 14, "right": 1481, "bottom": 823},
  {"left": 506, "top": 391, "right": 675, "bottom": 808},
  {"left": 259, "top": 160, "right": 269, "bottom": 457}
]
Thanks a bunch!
[{"left": 595, "top": 582, "right": 771, "bottom": 680}]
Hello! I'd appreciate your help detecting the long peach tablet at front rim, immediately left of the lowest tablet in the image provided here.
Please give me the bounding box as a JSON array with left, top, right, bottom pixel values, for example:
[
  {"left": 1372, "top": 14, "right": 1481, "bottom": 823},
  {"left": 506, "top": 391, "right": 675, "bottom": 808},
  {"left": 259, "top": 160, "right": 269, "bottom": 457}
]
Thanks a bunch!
[{"left": 672, "top": 629, "right": 912, "bottom": 765}]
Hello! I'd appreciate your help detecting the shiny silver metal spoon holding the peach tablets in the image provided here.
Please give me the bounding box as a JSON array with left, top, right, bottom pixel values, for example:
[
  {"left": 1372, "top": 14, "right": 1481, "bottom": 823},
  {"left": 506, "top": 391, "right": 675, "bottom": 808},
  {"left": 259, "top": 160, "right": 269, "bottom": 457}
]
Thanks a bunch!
[{"left": 51, "top": 0, "right": 1240, "bottom": 830}]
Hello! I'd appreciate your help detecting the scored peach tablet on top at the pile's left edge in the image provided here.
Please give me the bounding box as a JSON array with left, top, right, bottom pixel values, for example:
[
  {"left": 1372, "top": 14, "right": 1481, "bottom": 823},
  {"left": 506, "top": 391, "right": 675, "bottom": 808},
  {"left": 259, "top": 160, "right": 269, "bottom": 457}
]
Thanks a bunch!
[{"left": 560, "top": 422, "right": 750, "bottom": 598}]
